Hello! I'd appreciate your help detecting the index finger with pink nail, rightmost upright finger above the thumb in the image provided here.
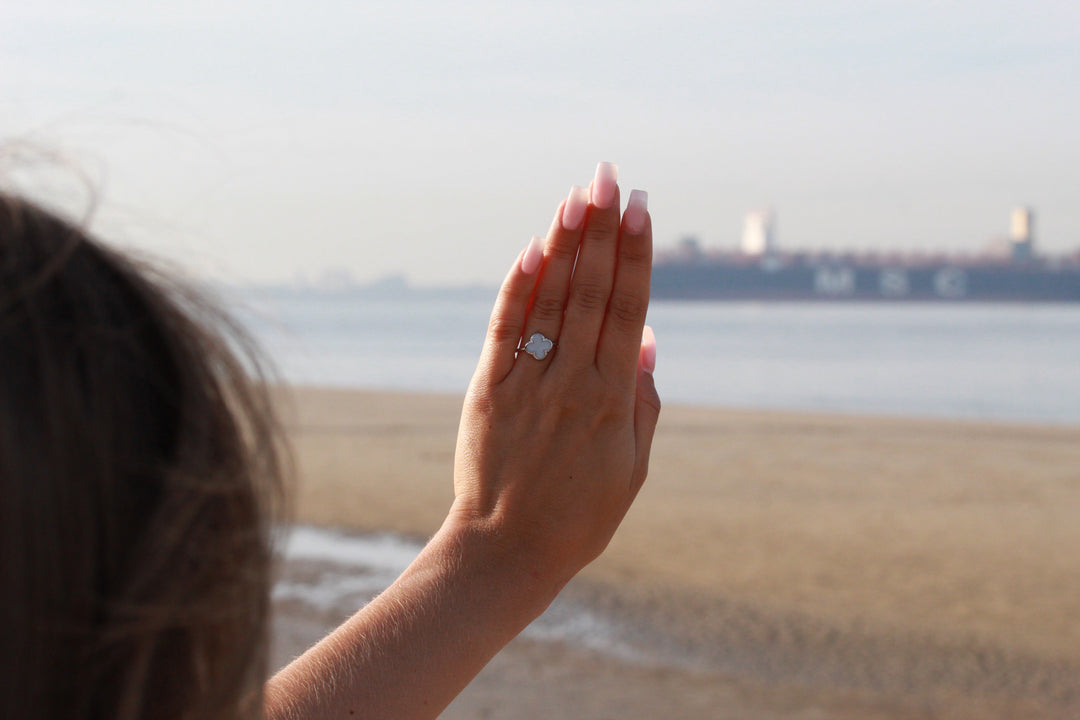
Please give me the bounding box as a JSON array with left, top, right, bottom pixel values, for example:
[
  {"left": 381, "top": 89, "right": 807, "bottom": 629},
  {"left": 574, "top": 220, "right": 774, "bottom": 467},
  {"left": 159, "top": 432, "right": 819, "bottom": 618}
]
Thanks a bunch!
[{"left": 596, "top": 190, "right": 652, "bottom": 383}]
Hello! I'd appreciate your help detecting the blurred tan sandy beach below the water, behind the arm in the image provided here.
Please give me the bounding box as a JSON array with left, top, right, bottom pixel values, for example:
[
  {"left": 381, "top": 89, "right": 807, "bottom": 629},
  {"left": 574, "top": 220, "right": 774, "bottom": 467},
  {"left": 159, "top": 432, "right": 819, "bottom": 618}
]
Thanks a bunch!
[{"left": 274, "top": 389, "right": 1080, "bottom": 720}]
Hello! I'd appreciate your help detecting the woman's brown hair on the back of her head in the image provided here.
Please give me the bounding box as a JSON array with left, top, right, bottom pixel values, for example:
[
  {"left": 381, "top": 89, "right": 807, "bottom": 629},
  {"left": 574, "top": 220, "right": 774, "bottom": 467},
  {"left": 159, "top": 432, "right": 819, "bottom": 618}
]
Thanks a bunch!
[{"left": 0, "top": 194, "right": 283, "bottom": 720}]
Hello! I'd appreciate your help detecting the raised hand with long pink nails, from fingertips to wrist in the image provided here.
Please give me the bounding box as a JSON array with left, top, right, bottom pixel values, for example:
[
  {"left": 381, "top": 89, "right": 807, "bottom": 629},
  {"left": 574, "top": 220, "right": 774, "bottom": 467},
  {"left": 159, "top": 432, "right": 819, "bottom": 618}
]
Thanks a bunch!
[{"left": 451, "top": 163, "right": 660, "bottom": 597}]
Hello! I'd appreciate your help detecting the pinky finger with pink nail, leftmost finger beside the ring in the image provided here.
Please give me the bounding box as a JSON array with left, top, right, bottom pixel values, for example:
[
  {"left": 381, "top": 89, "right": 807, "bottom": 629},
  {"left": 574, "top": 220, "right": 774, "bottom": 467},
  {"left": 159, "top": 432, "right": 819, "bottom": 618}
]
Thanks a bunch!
[{"left": 476, "top": 235, "right": 543, "bottom": 383}]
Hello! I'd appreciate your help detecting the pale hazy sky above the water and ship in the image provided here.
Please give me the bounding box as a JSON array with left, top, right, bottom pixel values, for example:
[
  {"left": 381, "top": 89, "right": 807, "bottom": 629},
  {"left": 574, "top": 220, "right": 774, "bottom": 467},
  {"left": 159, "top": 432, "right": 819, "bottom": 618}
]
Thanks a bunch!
[{"left": 0, "top": 0, "right": 1080, "bottom": 285}]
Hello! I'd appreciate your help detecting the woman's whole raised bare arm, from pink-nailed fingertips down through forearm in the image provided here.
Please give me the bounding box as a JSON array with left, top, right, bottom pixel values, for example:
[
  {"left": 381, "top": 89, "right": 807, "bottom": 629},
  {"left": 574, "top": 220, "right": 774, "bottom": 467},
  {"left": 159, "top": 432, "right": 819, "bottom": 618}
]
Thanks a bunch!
[{"left": 266, "top": 163, "right": 660, "bottom": 720}]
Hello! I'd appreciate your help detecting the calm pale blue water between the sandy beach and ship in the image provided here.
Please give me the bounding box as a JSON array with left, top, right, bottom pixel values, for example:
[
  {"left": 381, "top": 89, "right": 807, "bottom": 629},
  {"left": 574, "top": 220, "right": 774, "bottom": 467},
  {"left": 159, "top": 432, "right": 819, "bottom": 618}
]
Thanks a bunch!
[{"left": 240, "top": 290, "right": 1080, "bottom": 424}]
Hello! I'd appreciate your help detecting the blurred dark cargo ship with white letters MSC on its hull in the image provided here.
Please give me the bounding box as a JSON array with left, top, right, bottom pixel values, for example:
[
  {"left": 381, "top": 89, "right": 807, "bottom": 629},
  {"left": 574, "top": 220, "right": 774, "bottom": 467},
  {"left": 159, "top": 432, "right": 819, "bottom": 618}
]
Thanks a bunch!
[{"left": 652, "top": 207, "right": 1080, "bottom": 302}]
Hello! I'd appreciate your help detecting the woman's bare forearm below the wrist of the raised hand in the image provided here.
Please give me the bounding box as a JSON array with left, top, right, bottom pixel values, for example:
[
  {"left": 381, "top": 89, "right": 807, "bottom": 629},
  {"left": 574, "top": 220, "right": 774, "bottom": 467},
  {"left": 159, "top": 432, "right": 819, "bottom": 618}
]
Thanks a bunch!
[{"left": 266, "top": 515, "right": 561, "bottom": 720}]
